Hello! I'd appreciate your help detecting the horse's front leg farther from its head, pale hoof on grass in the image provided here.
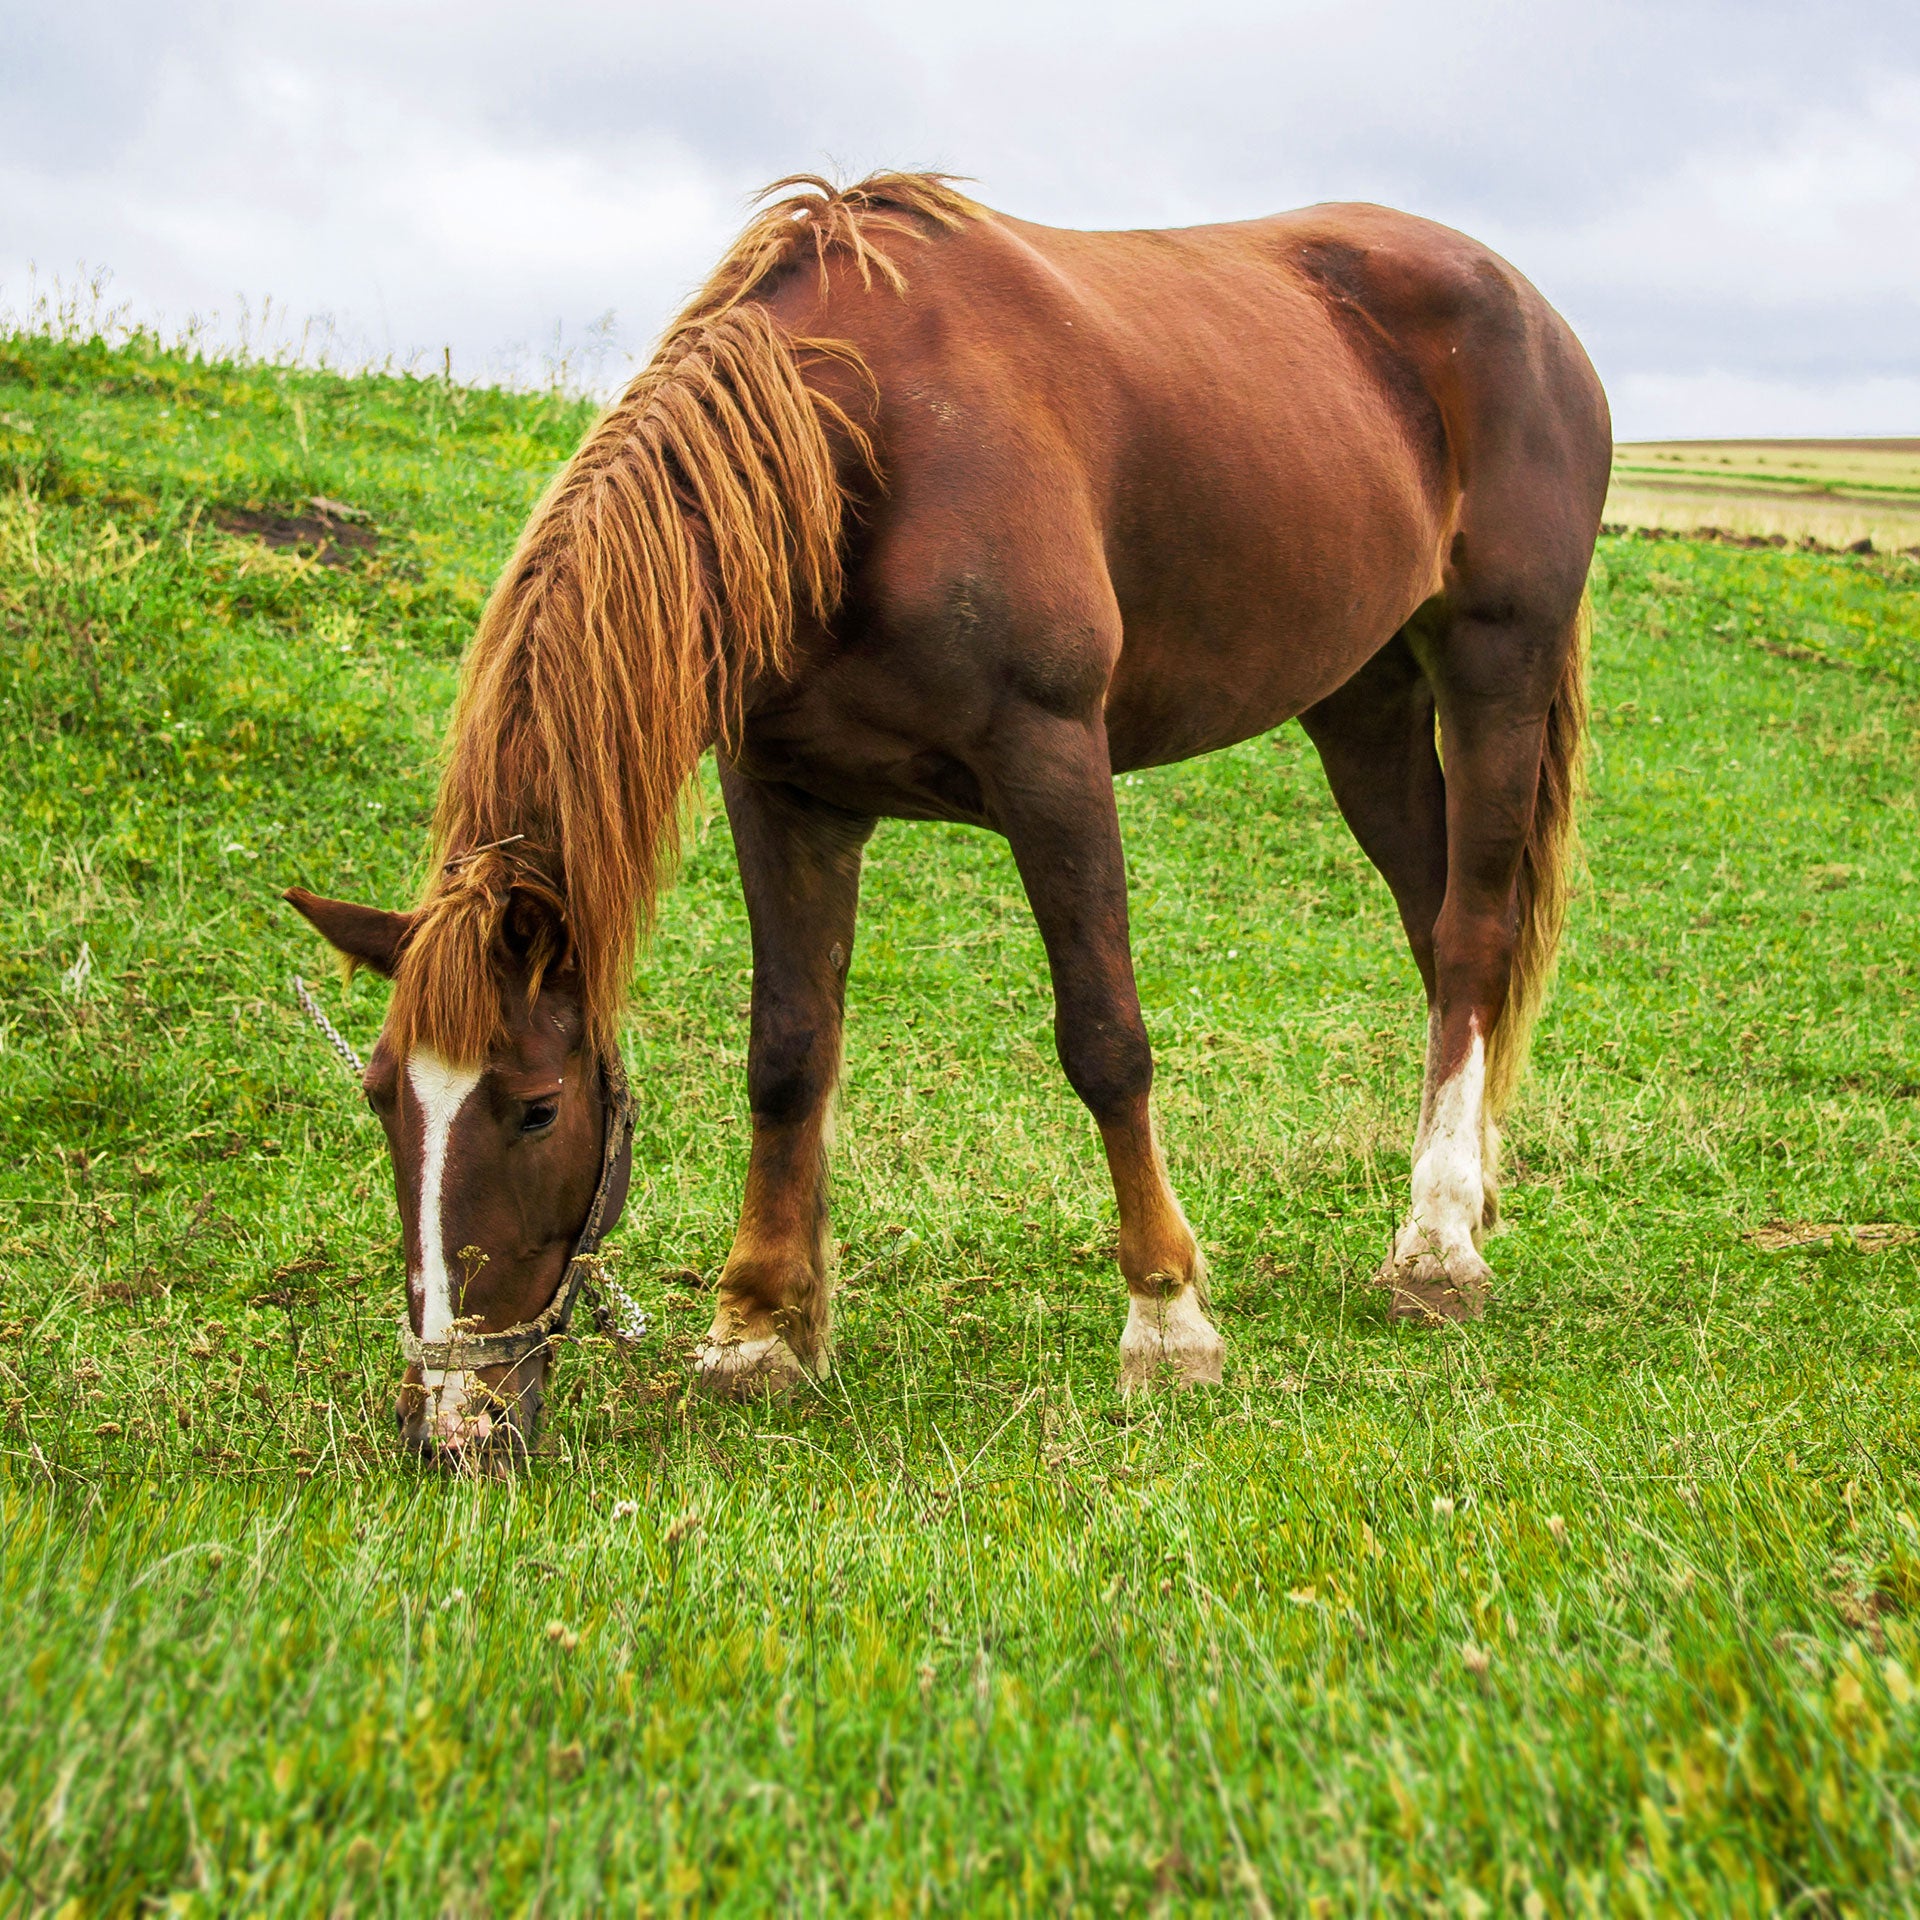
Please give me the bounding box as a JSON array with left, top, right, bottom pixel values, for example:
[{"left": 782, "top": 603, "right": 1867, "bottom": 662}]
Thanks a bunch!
[{"left": 983, "top": 714, "right": 1223, "bottom": 1392}]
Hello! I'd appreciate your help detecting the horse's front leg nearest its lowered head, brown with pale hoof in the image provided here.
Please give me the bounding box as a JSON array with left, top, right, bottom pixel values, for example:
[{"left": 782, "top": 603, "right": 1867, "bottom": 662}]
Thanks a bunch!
[{"left": 695, "top": 760, "right": 874, "bottom": 1394}]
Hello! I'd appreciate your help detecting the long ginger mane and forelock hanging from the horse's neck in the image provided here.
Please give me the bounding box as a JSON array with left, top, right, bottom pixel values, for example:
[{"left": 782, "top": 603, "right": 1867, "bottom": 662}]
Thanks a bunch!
[{"left": 390, "top": 173, "right": 975, "bottom": 1062}]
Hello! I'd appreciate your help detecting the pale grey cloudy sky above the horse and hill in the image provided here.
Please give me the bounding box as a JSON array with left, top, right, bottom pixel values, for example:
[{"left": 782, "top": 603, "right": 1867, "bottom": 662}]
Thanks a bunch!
[{"left": 0, "top": 0, "right": 1920, "bottom": 438}]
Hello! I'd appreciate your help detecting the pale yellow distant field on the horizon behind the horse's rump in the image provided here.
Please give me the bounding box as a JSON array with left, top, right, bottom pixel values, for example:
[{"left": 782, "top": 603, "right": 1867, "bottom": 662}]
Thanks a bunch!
[{"left": 1607, "top": 440, "right": 1920, "bottom": 553}]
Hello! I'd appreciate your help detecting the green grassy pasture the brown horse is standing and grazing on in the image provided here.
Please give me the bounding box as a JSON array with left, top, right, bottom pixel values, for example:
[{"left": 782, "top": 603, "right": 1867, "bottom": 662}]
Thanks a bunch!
[{"left": 0, "top": 338, "right": 1920, "bottom": 1916}]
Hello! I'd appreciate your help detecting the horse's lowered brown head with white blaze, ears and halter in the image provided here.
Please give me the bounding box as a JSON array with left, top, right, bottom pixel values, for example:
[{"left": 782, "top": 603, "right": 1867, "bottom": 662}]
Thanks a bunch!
[{"left": 286, "top": 887, "right": 632, "bottom": 1469}]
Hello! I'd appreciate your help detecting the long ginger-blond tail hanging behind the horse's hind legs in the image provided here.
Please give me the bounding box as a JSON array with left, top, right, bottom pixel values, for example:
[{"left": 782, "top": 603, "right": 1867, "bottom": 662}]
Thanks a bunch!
[{"left": 1486, "top": 595, "right": 1594, "bottom": 1119}]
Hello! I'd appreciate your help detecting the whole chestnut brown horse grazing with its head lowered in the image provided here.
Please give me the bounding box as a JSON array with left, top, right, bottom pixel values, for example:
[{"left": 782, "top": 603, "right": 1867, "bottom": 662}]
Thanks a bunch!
[{"left": 288, "top": 175, "right": 1611, "bottom": 1457}]
